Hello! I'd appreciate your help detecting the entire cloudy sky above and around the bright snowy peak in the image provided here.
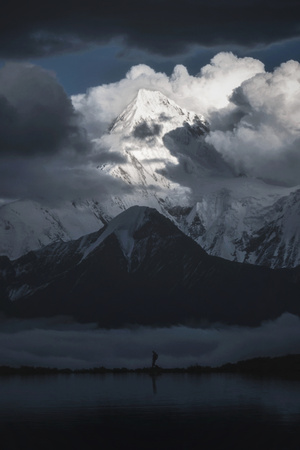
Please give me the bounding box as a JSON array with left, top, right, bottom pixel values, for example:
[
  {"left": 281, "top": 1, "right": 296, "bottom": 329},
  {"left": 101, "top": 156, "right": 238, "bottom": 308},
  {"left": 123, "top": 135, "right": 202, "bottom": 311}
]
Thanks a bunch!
[{"left": 0, "top": 0, "right": 300, "bottom": 202}]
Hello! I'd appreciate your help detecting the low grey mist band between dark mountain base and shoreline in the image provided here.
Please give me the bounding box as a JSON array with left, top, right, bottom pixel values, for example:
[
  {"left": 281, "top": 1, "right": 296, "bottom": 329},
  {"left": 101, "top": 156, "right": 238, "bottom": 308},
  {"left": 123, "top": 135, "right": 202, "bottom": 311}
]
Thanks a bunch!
[{"left": 0, "top": 313, "right": 300, "bottom": 369}]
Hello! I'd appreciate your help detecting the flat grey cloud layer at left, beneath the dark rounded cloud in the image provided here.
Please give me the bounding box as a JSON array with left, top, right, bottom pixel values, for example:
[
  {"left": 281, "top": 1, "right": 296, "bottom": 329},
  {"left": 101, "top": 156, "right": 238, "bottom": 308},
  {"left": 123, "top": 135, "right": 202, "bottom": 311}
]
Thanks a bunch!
[{"left": 0, "top": 155, "right": 131, "bottom": 207}]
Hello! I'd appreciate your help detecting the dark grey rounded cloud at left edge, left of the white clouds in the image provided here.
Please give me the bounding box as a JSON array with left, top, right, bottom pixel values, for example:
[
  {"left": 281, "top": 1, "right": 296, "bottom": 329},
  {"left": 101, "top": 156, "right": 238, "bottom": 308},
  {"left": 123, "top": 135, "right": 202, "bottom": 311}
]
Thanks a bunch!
[{"left": 0, "top": 63, "right": 88, "bottom": 156}]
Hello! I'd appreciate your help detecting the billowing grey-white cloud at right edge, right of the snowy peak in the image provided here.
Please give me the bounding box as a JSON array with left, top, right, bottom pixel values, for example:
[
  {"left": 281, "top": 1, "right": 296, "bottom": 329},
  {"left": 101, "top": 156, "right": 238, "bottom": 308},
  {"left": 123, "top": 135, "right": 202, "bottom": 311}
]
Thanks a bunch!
[{"left": 207, "top": 61, "right": 300, "bottom": 185}]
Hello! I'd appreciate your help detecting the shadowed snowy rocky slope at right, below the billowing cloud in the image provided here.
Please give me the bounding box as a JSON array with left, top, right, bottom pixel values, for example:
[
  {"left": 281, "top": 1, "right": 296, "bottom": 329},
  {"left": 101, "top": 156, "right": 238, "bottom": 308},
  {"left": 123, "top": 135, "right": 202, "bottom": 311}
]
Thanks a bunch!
[{"left": 181, "top": 177, "right": 300, "bottom": 268}]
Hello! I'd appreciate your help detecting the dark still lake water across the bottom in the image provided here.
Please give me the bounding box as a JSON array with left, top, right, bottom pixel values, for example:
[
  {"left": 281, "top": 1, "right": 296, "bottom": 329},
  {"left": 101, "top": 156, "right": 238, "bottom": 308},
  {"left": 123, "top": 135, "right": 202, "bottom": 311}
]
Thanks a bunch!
[{"left": 0, "top": 374, "right": 300, "bottom": 450}]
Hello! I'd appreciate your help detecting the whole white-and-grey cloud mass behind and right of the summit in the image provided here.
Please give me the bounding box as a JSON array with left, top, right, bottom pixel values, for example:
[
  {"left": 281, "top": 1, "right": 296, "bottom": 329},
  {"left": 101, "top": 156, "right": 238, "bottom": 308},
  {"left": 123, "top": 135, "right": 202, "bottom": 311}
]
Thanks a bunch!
[{"left": 72, "top": 52, "right": 300, "bottom": 185}]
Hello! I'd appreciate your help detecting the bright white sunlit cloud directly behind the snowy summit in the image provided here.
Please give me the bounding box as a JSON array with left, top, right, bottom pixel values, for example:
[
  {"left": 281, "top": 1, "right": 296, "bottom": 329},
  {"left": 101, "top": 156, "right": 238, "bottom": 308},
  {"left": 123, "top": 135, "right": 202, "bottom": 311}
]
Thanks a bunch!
[{"left": 72, "top": 52, "right": 264, "bottom": 138}]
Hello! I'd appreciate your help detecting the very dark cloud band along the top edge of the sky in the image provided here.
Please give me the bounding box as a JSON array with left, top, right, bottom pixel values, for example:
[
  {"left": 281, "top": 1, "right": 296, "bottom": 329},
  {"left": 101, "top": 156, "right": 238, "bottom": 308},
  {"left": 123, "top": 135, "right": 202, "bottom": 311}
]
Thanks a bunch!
[{"left": 0, "top": 0, "right": 300, "bottom": 58}]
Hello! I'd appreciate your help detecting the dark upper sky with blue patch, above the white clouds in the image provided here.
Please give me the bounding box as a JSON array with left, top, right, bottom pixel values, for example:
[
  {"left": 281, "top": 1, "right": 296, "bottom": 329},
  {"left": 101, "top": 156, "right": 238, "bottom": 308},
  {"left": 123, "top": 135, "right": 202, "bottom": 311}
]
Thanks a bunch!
[{"left": 0, "top": 0, "right": 300, "bottom": 94}]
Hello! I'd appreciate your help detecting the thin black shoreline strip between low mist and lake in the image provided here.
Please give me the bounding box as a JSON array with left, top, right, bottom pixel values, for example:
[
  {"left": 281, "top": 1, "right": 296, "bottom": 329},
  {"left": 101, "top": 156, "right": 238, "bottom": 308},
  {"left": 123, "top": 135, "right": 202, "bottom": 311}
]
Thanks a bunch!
[{"left": 0, "top": 354, "right": 300, "bottom": 380}]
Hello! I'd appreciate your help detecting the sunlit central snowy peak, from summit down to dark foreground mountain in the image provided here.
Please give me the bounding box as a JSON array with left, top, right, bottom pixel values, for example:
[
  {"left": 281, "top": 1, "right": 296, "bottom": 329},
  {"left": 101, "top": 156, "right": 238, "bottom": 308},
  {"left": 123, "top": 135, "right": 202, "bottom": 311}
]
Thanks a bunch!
[{"left": 97, "top": 89, "right": 232, "bottom": 214}]
